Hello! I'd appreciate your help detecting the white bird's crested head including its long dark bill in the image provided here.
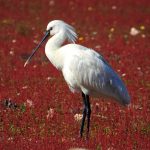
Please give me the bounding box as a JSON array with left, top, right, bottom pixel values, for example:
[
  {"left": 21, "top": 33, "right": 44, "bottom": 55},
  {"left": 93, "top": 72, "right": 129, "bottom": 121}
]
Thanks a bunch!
[{"left": 24, "top": 20, "right": 77, "bottom": 67}]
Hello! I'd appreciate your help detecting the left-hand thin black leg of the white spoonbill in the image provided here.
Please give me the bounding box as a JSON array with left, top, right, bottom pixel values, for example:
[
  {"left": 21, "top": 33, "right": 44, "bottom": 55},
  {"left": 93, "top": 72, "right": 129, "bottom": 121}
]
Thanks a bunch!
[{"left": 80, "top": 93, "right": 87, "bottom": 137}]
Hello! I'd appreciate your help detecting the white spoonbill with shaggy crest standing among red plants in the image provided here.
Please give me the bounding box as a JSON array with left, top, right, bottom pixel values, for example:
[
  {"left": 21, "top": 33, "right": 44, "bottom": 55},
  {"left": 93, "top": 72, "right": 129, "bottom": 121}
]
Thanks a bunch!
[{"left": 24, "top": 20, "right": 131, "bottom": 137}]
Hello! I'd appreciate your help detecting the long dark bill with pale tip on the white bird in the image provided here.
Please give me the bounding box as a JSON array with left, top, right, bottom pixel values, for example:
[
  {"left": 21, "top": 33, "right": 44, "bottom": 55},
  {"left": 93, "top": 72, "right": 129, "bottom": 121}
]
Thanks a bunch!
[{"left": 24, "top": 31, "right": 49, "bottom": 67}]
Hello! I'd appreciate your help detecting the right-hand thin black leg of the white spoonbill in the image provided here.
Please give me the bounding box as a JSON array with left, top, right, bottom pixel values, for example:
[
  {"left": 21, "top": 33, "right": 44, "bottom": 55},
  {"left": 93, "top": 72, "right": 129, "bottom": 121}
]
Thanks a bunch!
[{"left": 86, "top": 95, "right": 91, "bottom": 136}]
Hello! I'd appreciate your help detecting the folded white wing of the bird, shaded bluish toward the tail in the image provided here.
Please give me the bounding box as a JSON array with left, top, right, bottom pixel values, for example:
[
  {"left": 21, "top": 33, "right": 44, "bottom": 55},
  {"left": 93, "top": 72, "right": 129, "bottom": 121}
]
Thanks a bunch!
[{"left": 62, "top": 44, "right": 129, "bottom": 104}]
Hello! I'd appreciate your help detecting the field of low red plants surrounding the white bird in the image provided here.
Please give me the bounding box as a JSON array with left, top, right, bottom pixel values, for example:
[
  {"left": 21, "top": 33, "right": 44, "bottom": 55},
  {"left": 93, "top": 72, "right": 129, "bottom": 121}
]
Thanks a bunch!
[{"left": 0, "top": 0, "right": 150, "bottom": 150}]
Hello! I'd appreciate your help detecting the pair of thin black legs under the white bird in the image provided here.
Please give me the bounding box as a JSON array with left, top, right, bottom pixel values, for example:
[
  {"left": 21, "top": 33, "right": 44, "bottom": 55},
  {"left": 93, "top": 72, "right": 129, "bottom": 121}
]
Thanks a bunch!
[{"left": 80, "top": 93, "right": 91, "bottom": 137}]
